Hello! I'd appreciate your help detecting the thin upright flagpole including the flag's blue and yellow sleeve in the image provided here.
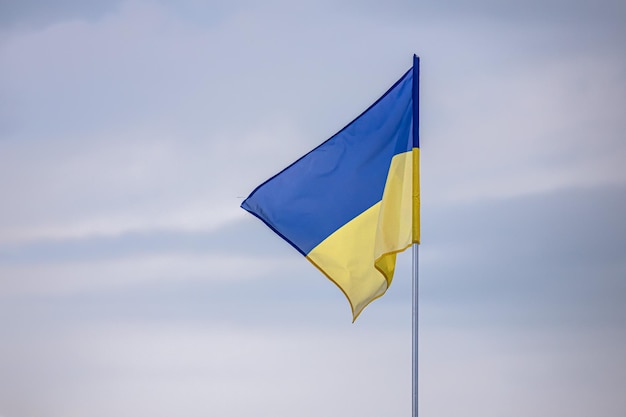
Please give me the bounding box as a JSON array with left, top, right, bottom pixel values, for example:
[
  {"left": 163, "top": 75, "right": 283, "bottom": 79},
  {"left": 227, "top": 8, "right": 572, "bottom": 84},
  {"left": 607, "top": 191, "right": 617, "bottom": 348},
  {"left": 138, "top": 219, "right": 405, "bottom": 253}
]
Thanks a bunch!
[{"left": 411, "top": 55, "right": 421, "bottom": 417}]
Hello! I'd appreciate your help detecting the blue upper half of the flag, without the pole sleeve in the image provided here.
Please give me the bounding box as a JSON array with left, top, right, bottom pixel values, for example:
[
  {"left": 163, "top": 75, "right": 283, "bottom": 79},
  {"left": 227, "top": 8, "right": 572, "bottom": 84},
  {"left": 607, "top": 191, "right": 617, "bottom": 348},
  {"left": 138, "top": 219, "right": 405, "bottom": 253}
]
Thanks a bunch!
[{"left": 241, "top": 70, "right": 414, "bottom": 255}]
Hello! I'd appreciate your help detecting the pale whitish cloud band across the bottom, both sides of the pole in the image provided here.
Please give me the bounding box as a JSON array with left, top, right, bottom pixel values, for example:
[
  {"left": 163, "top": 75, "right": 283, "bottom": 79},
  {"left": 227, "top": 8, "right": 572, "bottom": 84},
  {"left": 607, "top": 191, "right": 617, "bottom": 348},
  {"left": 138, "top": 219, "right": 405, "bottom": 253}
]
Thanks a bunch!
[{"left": 0, "top": 321, "right": 626, "bottom": 417}]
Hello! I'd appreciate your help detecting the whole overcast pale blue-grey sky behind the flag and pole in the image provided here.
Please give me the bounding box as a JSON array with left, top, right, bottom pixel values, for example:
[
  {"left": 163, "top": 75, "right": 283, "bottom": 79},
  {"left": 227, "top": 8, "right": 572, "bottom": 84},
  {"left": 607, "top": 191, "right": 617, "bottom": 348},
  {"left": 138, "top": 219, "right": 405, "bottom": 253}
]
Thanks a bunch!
[{"left": 0, "top": 0, "right": 626, "bottom": 417}]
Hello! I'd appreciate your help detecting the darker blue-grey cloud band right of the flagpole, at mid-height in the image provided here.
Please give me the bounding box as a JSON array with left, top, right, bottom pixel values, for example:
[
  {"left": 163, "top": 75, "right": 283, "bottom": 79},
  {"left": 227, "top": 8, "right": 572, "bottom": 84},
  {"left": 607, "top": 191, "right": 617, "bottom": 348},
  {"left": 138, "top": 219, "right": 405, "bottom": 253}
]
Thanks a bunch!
[{"left": 422, "top": 186, "right": 626, "bottom": 326}]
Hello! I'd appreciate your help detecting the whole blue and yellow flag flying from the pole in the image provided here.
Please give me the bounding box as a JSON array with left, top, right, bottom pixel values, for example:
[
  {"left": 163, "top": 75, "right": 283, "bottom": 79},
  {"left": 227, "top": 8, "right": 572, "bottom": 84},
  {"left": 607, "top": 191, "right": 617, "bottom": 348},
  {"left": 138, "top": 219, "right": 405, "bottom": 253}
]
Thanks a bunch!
[{"left": 241, "top": 56, "right": 420, "bottom": 320}]
